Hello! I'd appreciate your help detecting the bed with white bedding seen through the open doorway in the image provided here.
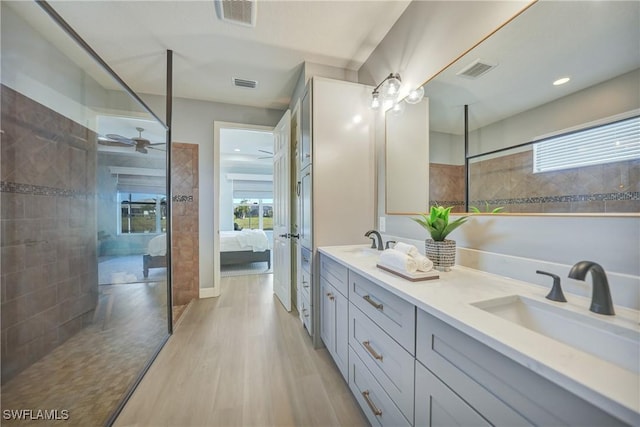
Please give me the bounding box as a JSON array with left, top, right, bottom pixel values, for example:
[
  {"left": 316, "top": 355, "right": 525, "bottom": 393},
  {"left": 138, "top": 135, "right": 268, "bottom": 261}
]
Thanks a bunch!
[{"left": 220, "top": 230, "right": 271, "bottom": 269}]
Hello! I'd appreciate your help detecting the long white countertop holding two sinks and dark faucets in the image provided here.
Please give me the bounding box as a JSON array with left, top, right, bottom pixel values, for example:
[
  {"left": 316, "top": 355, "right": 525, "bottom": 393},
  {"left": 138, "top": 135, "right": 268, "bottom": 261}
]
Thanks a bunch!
[{"left": 319, "top": 245, "right": 640, "bottom": 425}]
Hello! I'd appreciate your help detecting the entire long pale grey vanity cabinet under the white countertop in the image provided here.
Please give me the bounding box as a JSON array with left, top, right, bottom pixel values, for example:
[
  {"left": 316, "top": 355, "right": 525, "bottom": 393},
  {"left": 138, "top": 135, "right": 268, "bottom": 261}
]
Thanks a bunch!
[{"left": 320, "top": 247, "right": 637, "bottom": 427}]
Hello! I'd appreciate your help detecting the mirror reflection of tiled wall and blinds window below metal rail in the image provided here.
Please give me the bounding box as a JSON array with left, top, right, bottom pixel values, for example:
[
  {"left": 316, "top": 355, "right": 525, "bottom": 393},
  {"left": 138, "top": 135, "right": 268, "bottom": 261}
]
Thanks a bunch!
[{"left": 469, "top": 116, "right": 640, "bottom": 213}]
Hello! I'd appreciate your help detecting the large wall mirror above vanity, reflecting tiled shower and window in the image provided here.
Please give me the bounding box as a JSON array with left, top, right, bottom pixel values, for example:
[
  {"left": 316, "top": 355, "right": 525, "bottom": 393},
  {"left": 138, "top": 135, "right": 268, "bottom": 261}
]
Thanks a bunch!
[{"left": 412, "top": 1, "right": 640, "bottom": 214}]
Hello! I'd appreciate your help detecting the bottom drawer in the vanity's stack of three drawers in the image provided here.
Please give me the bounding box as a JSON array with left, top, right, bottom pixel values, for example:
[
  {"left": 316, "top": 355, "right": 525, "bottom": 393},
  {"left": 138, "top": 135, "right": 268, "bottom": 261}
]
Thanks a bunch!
[{"left": 349, "top": 347, "right": 413, "bottom": 427}]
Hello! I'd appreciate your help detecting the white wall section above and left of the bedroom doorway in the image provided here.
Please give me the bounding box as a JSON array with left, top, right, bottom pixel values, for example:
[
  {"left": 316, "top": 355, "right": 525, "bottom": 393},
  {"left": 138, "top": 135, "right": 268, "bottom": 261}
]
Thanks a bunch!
[{"left": 141, "top": 95, "right": 283, "bottom": 288}]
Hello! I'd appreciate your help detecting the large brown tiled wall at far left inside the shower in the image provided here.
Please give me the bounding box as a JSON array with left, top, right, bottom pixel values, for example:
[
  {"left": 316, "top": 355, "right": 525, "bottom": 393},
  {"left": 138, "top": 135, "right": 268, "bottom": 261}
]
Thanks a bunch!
[{"left": 0, "top": 85, "right": 98, "bottom": 383}]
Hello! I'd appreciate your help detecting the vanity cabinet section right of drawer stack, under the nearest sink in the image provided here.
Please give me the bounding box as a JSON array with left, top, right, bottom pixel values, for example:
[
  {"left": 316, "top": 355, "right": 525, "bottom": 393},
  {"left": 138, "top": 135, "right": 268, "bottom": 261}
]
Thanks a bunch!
[{"left": 415, "top": 310, "right": 625, "bottom": 426}]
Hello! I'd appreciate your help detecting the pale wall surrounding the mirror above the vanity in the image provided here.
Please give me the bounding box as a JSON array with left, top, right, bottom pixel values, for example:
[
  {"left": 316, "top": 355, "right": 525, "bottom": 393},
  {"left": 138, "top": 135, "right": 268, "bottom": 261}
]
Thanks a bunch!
[{"left": 359, "top": 2, "right": 640, "bottom": 307}]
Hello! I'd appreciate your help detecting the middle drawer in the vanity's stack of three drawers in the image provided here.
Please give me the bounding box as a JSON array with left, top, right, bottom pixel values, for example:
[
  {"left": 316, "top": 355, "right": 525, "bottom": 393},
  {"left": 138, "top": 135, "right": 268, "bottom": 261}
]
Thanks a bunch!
[{"left": 349, "top": 305, "right": 414, "bottom": 420}]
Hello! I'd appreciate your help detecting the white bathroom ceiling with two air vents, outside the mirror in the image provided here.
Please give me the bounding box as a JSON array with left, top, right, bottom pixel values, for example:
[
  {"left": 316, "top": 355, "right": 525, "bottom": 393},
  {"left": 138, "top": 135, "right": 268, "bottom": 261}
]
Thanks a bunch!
[{"left": 41, "top": 0, "right": 410, "bottom": 109}]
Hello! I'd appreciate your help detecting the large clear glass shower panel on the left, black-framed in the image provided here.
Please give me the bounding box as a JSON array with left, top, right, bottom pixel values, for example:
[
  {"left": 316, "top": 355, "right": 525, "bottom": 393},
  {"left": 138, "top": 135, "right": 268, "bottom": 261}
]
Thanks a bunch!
[{"left": 0, "top": 1, "right": 169, "bottom": 425}]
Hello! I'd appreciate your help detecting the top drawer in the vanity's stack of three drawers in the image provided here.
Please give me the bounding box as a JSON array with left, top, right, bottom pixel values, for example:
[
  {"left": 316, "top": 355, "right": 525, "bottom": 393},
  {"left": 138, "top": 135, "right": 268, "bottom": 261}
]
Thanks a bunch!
[{"left": 349, "top": 271, "right": 416, "bottom": 355}]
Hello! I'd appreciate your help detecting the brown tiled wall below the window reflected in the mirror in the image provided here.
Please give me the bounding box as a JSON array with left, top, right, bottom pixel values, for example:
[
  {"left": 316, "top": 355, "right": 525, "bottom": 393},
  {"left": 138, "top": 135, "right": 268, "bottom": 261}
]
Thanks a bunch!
[{"left": 469, "top": 150, "right": 640, "bottom": 213}]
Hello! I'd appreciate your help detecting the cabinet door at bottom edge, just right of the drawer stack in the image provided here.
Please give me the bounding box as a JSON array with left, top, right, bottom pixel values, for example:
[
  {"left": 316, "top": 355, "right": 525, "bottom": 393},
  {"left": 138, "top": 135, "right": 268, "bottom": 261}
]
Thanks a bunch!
[{"left": 415, "top": 362, "right": 491, "bottom": 427}]
